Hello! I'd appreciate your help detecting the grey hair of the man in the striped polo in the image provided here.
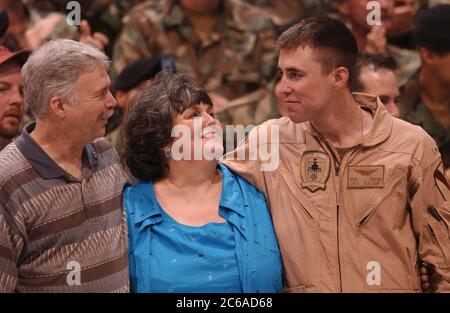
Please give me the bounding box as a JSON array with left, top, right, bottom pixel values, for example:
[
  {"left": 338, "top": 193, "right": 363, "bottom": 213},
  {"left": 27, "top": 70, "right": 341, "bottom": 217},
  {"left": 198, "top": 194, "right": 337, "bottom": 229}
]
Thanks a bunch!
[{"left": 22, "top": 39, "right": 110, "bottom": 118}]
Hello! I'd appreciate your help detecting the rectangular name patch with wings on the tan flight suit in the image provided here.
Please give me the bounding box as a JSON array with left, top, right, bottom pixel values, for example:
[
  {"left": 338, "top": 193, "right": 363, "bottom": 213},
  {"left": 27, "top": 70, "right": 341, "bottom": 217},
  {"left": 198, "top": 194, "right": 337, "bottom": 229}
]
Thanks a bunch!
[{"left": 347, "top": 165, "right": 384, "bottom": 189}]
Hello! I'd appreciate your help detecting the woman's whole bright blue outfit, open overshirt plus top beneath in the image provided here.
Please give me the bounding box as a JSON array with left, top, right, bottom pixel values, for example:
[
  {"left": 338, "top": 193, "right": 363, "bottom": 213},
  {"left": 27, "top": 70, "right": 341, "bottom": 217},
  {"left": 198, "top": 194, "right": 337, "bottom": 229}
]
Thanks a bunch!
[{"left": 124, "top": 164, "right": 282, "bottom": 292}]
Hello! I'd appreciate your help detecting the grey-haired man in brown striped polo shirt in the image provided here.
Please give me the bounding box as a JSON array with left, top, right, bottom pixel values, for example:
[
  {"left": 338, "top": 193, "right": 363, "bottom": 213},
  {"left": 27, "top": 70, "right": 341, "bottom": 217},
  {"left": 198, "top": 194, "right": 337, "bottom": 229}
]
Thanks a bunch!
[{"left": 0, "top": 40, "right": 129, "bottom": 292}]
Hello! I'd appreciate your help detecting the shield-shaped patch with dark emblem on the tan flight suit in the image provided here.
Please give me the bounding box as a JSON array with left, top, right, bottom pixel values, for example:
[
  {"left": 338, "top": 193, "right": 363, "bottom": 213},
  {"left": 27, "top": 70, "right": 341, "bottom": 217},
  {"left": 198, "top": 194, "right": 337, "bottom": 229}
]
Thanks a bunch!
[{"left": 300, "top": 151, "right": 330, "bottom": 192}]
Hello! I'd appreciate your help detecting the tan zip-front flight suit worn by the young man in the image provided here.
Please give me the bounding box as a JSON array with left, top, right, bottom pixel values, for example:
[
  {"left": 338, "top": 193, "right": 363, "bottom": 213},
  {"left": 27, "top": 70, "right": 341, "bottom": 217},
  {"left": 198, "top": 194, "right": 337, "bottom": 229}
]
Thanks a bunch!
[{"left": 224, "top": 93, "right": 450, "bottom": 292}]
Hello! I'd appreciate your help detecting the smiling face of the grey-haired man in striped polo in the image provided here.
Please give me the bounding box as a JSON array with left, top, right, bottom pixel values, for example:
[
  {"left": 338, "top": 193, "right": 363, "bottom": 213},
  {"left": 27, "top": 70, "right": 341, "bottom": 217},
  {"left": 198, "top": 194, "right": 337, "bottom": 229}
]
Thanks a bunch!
[{"left": 66, "top": 67, "right": 117, "bottom": 143}]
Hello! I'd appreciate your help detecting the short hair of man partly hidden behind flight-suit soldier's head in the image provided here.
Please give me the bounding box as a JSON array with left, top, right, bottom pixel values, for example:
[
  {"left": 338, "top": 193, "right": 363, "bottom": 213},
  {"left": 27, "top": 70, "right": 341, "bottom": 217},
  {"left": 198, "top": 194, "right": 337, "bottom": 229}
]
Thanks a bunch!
[{"left": 351, "top": 53, "right": 397, "bottom": 91}]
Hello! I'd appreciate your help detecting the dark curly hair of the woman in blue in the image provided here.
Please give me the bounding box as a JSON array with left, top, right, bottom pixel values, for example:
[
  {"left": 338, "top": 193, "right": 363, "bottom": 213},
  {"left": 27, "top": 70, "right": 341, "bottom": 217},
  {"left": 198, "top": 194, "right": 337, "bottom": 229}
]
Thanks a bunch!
[{"left": 124, "top": 72, "right": 213, "bottom": 181}]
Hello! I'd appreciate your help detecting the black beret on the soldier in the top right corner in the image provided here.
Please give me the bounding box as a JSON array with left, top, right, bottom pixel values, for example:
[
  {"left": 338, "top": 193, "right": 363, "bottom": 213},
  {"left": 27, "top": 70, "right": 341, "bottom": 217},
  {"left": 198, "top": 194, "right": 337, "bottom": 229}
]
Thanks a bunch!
[{"left": 414, "top": 4, "right": 450, "bottom": 52}]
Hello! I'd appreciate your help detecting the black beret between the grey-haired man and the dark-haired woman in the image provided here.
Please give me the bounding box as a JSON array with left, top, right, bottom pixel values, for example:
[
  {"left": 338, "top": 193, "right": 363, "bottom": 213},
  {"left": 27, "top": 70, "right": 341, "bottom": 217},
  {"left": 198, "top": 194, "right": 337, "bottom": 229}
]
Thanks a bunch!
[{"left": 113, "top": 58, "right": 161, "bottom": 91}]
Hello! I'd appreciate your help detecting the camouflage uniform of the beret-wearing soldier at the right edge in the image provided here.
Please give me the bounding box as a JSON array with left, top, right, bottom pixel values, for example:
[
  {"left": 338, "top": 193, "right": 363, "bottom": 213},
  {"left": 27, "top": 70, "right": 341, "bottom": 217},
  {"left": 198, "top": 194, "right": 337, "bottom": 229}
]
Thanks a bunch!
[{"left": 400, "top": 72, "right": 450, "bottom": 169}]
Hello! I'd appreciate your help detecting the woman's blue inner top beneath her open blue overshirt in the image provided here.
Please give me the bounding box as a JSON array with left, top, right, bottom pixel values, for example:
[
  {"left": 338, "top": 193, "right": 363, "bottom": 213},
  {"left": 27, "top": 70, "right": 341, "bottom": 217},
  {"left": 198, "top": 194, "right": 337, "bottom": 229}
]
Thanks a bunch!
[{"left": 150, "top": 209, "right": 242, "bottom": 293}]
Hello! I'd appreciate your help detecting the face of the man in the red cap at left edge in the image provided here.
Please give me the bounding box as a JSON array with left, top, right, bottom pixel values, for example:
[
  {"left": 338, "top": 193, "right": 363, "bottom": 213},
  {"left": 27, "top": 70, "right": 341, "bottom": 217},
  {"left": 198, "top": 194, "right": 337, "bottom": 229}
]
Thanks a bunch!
[{"left": 0, "top": 62, "right": 23, "bottom": 138}]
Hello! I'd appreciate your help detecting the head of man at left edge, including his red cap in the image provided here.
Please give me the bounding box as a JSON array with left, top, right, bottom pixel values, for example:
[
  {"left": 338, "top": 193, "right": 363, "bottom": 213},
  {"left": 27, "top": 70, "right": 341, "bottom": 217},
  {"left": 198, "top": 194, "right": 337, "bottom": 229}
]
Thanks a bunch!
[{"left": 0, "top": 46, "right": 29, "bottom": 150}]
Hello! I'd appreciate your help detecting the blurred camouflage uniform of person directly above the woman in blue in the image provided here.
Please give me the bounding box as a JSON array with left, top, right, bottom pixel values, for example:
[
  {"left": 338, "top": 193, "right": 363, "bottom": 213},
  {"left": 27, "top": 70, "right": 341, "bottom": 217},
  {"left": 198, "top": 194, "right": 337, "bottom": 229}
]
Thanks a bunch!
[{"left": 113, "top": 0, "right": 277, "bottom": 109}]
